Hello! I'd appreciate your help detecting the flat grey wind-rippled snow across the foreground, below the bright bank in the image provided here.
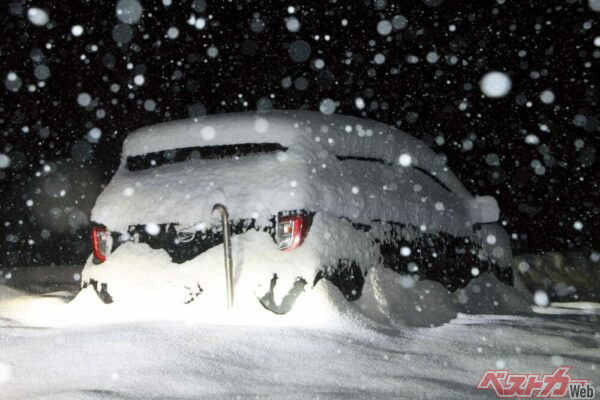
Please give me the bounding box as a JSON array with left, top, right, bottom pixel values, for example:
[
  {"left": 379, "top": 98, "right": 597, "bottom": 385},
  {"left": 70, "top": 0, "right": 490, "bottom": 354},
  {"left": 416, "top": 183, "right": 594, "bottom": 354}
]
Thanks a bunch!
[{"left": 0, "top": 315, "right": 600, "bottom": 399}]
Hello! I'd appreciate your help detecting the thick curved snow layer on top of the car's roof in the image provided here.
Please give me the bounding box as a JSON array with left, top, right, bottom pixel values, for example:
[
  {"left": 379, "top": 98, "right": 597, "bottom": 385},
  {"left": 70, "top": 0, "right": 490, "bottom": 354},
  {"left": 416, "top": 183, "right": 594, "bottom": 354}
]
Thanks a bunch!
[{"left": 123, "top": 110, "right": 471, "bottom": 199}]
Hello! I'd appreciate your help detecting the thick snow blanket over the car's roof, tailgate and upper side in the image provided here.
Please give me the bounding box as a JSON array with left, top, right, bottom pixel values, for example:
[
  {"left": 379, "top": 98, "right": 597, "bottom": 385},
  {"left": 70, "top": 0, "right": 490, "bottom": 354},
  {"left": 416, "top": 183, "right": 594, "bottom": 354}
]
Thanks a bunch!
[{"left": 92, "top": 111, "right": 498, "bottom": 235}]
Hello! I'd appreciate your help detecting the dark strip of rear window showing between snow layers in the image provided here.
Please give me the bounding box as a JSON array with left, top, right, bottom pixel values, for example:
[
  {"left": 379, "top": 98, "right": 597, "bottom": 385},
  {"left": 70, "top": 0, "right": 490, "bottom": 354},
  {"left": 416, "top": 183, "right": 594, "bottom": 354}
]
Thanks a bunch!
[{"left": 127, "top": 143, "right": 287, "bottom": 171}]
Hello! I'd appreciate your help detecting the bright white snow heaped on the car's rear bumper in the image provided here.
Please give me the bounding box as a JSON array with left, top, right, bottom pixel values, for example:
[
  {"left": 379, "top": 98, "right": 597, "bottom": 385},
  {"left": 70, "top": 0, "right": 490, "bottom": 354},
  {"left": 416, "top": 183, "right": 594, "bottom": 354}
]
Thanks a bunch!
[{"left": 82, "top": 231, "right": 321, "bottom": 308}]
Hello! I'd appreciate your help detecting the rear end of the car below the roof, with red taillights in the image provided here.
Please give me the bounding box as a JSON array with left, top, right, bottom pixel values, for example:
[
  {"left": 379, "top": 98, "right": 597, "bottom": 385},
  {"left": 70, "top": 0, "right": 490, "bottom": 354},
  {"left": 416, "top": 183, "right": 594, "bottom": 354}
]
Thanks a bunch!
[{"left": 82, "top": 131, "right": 319, "bottom": 310}]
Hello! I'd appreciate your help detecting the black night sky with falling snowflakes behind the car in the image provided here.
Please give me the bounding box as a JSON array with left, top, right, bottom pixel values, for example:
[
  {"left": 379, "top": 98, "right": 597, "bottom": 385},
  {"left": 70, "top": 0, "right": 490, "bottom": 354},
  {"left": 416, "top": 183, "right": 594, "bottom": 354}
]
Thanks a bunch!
[{"left": 0, "top": 0, "right": 600, "bottom": 266}]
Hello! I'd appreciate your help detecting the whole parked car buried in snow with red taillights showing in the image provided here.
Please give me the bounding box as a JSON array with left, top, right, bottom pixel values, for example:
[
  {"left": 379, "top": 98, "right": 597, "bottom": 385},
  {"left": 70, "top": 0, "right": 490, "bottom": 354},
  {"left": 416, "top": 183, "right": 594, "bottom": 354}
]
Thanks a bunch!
[{"left": 82, "top": 111, "right": 512, "bottom": 314}]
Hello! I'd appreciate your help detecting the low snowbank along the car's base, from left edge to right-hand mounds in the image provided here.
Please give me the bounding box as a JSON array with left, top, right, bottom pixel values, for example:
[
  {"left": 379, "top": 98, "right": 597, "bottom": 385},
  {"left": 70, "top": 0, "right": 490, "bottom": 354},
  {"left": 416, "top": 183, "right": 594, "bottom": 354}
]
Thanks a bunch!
[{"left": 0, "top": 268, "right": 530, "bottom": 335}]
